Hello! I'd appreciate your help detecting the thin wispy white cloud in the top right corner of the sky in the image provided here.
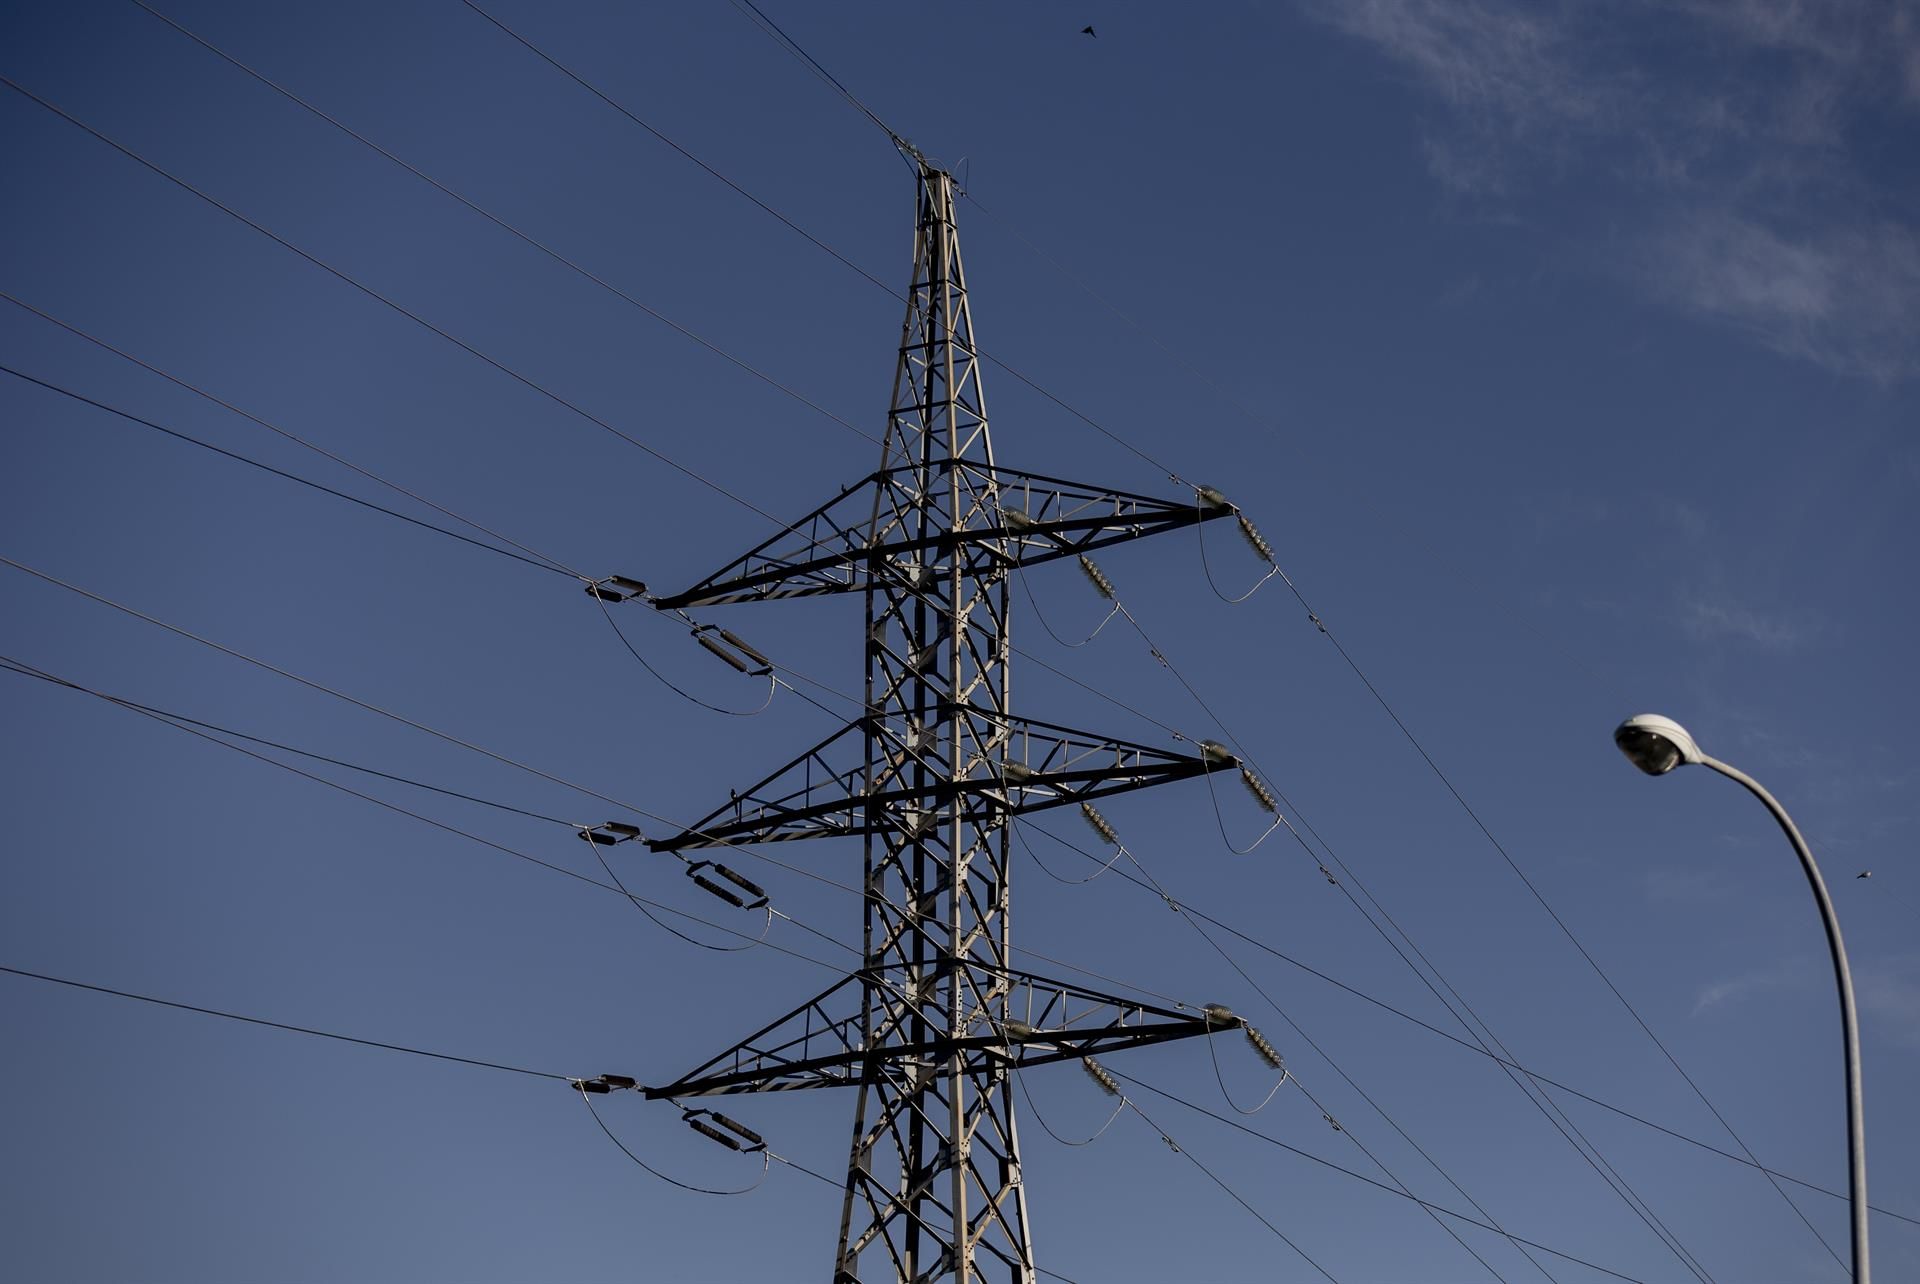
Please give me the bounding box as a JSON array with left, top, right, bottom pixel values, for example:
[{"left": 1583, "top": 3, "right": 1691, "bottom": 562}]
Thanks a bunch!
[{"left": 1302, "top": 0, "right": 1920, "bottom": 382}]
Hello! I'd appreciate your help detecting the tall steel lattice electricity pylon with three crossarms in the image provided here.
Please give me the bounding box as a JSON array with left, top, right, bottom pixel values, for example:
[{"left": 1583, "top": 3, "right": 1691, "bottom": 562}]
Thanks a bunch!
[{"left": 633, "top": 154, "right": 1238, "bottom": 1284}]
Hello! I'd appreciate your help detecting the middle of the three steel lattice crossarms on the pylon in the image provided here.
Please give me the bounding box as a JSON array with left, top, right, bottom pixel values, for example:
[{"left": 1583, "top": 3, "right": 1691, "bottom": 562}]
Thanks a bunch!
[{"left": 647, "top": 704, "right": 1238, "bottom": 852}]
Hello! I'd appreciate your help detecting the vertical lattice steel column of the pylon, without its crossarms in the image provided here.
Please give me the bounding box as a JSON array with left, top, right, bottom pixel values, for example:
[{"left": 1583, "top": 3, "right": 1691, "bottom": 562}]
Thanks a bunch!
[{"left": 835, "top": 161, "right": 1033, "bottom": 1284}]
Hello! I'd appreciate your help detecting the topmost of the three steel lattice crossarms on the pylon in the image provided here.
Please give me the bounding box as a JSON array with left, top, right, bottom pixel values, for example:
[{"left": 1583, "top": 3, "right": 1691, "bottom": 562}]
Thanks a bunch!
[{"left": 653, "top": 459, "right": 1235, "bottom": 610}]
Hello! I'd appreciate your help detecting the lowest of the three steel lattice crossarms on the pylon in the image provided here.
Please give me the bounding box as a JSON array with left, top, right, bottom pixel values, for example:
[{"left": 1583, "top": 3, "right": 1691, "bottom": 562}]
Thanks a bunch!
[{"left": 643, "top": 963, "right": 1240, "bottom": 1100}]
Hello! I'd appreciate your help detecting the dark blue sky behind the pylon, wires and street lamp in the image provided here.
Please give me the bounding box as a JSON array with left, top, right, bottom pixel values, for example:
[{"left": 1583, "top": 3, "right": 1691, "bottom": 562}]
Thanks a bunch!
[{"left": 0, "top": 0, "right": 1920, "bottom": 1284}]
